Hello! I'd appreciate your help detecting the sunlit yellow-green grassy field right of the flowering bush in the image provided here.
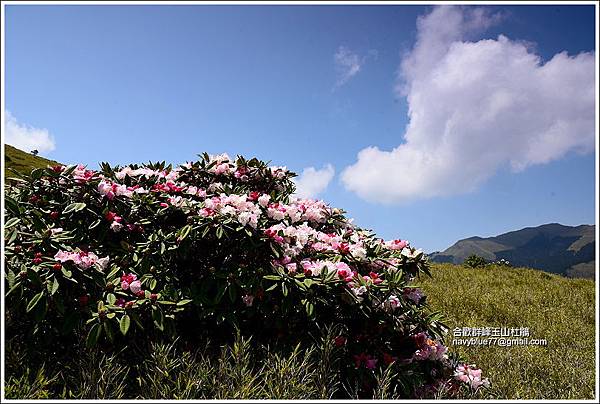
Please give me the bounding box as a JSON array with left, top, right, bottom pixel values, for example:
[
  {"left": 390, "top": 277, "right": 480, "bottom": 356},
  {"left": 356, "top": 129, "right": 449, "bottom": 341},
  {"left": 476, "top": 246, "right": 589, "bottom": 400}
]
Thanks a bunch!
[{"left": 421, "top": 264, "right": 596, "bottom": 399}]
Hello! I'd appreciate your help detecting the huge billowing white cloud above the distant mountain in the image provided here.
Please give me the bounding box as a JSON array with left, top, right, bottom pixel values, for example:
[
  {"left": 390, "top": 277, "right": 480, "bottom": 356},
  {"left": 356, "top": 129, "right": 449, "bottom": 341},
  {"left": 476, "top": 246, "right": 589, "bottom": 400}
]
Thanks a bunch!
[{"left": 341, "top": 6, "right": 596, "bottom": 203}]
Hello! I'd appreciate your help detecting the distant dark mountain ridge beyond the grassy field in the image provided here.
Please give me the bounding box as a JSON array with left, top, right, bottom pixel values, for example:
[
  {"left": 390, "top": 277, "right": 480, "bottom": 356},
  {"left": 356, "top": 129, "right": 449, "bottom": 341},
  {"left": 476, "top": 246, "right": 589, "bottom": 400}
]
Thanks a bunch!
[{"left": 429, "top": 223, "right": 596, "bottom": 279}]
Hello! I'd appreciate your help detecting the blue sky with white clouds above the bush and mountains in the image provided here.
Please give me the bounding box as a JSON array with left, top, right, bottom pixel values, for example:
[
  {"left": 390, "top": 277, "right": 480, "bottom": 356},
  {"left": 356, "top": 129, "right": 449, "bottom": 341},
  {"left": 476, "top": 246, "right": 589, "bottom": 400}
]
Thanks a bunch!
[{"left": 5, "top": 6, "right": 595, "bottom": 251}]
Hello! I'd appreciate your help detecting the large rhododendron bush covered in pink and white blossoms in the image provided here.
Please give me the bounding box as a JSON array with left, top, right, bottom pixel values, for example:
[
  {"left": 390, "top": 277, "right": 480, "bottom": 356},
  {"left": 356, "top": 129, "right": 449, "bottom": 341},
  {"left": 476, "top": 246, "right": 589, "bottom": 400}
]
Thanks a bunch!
[{"left": 5, "top": 154, "right": 486, "bottom": 396}]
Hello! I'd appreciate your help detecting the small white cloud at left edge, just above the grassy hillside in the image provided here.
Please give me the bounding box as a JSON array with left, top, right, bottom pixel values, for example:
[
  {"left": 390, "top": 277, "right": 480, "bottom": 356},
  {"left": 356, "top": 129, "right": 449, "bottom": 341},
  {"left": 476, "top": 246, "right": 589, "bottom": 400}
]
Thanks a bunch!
[{"left": 4, "top": 111, "right": 56, "bottom": 153}]
